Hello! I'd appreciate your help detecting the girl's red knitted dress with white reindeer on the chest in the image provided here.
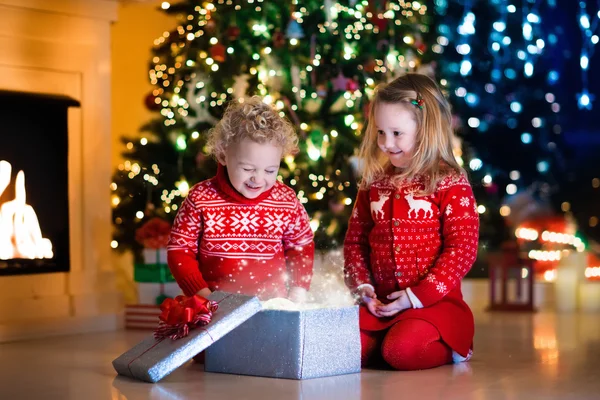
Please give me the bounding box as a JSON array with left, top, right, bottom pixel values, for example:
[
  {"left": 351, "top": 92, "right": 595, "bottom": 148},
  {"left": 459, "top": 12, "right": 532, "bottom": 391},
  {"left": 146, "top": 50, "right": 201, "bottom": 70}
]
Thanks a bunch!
[{"left": 344, "top": 173, "right": 479, "bottom": 356}]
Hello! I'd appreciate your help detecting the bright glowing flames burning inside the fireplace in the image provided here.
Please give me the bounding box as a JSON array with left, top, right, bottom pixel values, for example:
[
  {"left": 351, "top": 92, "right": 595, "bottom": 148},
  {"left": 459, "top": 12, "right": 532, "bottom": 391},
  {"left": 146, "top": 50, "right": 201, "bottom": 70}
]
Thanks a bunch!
[{"left": 0, "top": 161, "right": 54, "bottom": 260}]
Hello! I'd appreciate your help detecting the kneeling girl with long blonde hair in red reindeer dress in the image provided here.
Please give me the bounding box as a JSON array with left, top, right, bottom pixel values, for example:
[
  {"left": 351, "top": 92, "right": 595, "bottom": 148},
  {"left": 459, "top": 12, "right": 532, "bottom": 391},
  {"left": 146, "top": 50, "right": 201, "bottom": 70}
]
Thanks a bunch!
[{"left": 344, "top": 74, "right": 479, "bottom": 370}]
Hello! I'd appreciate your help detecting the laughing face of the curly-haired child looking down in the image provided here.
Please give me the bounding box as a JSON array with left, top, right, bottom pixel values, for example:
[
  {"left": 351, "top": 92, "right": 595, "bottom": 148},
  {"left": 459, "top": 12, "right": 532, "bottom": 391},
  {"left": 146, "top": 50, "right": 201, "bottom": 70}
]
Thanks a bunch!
[{"left": 221, "top": 139, "right": 283, "bottom": 199}]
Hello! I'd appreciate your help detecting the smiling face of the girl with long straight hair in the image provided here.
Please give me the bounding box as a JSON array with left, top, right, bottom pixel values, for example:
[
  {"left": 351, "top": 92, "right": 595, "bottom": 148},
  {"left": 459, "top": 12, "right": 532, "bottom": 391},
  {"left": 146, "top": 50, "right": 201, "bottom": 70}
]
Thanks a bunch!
[{"left": 375, "top": 103, "right": 417, "bottom": 168}]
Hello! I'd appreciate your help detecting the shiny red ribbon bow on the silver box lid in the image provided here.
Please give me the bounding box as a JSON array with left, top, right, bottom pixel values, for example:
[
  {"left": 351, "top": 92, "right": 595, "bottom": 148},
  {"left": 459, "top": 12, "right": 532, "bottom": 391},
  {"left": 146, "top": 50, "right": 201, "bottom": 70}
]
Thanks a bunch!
[{"left": 154, "top": 294, "right": 219, "bottom": 340}]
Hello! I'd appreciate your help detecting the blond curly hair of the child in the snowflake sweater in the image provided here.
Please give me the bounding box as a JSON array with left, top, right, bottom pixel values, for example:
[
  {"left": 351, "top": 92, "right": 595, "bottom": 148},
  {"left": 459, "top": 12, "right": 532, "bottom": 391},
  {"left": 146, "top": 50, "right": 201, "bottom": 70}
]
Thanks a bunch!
[{"left": 207, "top": 96, "right": 298, "bottom": 161}]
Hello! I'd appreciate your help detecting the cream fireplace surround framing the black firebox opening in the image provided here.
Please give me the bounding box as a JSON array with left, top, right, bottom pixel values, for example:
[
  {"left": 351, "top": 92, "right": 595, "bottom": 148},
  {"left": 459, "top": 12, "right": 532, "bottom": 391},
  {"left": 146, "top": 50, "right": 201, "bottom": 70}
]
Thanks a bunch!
[{"left": 0, "top": 0, "right": 122, "bottom": 342}]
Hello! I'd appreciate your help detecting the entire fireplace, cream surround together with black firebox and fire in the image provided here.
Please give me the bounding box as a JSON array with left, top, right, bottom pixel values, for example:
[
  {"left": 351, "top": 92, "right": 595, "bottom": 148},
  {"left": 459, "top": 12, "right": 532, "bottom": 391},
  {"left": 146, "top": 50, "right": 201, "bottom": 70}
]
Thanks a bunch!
[{"left": 0, "top": 0, "right": 123, "bottom": 342}]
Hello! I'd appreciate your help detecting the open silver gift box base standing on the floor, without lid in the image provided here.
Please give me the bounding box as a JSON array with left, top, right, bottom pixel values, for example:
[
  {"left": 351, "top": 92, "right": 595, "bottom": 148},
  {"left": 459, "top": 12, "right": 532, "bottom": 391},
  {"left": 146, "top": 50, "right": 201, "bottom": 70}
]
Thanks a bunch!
[{"left": 205, "top": 306, "right": 360, "bottom": 379}]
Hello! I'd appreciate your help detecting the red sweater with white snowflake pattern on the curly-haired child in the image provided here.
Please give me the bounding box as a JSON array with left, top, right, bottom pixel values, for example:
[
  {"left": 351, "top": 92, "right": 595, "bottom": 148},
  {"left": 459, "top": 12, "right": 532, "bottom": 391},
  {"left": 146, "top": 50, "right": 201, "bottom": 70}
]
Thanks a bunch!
[{"left": 167, "top": 166, "right": 314, "bottom": 299}]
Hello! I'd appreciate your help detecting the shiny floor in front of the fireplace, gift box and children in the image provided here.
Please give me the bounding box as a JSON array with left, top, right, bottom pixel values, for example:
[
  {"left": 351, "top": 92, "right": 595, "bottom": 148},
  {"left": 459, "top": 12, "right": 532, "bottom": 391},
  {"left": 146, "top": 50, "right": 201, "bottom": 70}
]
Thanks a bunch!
[{"left": 0, "top": 314, "right": 600, "bottom": 400}]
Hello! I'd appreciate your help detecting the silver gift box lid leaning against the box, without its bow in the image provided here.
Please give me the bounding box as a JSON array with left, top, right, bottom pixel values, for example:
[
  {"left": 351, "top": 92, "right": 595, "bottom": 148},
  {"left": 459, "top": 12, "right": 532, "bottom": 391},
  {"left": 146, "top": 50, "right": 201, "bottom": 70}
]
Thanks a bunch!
[{"left": 113, "top": 292, "right": 262, "bottom": 383}]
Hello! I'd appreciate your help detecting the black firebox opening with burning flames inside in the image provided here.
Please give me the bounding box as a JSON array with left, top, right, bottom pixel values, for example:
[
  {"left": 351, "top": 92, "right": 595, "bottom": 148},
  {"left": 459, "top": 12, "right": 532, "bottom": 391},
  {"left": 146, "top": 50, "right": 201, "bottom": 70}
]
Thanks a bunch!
[{"left": 0, "top": 91, "right": 79, "bottom": 275}]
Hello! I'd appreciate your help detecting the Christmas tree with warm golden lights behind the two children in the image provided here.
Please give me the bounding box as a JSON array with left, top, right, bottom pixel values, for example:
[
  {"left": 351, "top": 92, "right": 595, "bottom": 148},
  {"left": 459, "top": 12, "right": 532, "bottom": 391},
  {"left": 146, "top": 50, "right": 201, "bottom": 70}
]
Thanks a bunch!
[{"left": 112, "top": 0, "right": 435, "bottom": 253}]
